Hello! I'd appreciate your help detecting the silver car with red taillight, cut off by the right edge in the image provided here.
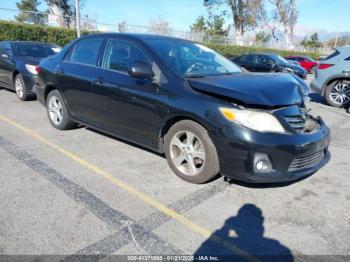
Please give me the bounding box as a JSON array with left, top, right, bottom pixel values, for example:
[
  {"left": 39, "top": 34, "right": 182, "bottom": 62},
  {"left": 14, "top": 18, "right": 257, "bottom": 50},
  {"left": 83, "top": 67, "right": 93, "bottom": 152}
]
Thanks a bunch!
[{"left": 310, "top": 46, "right": 350, "bottom": 107}]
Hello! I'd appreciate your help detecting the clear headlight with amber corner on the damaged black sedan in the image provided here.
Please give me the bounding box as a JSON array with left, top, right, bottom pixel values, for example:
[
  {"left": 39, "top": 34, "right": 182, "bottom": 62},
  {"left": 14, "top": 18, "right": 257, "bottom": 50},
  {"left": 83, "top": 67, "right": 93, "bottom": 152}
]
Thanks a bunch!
[{"left": 219, "top": 107, "right": 285, "bottom": 132}]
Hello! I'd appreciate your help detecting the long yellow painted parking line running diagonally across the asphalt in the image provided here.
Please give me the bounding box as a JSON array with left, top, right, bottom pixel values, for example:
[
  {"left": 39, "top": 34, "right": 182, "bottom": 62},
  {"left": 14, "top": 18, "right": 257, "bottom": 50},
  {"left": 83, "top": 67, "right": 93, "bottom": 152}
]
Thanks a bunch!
[{"left": 0, "top": 115, "right": 257, "bottom": 261}]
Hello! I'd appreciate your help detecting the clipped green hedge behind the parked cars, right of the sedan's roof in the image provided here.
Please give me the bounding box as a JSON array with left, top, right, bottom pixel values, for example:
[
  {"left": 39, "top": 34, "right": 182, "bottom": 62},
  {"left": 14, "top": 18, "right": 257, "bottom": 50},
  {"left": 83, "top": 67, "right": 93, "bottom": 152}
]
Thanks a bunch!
[{"left": 205, "top": 43, "right": 321, "bottom": 59}]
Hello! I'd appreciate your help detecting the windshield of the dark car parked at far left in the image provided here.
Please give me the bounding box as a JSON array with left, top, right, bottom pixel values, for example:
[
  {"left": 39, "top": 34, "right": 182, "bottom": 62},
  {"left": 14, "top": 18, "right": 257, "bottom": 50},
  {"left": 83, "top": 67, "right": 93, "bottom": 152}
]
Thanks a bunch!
[{"left": 14, "top": 43, "right": 60, "bottom": 58}]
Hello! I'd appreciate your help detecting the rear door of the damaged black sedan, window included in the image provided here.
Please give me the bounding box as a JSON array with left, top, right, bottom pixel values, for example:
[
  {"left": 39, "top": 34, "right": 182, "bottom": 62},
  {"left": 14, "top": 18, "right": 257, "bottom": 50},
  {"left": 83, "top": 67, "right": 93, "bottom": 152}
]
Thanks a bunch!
[{"left": 56, "top": 37, "right": 104, "bottom": 124}]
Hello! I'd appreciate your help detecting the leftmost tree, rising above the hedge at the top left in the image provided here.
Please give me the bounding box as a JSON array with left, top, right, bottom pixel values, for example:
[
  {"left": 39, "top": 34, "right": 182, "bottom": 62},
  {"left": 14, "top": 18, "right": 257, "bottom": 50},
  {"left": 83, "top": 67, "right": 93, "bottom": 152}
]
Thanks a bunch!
[{"left": 15, "top": 0, "right": 44, "bottom": 24}]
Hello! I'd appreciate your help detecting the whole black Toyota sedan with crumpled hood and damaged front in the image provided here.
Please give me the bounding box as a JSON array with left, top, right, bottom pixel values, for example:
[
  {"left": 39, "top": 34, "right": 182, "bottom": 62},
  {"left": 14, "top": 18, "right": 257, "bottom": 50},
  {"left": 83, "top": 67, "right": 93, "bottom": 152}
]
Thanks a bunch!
[{"left": 36, "top": 34, "right": 330, "bottom": 183}]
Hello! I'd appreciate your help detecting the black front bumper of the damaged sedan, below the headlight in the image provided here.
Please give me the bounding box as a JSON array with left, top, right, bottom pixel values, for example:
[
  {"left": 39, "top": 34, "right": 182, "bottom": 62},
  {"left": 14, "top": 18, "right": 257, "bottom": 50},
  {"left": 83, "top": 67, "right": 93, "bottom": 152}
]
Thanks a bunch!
[{"left": 211, "top": 118, "right": 330, "bottom": 183}]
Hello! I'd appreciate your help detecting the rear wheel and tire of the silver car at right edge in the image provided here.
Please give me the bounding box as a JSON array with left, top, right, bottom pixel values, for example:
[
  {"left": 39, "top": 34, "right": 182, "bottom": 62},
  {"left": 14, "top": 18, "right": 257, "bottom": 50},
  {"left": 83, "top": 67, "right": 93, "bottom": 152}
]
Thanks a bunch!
[{"left": 325, "top": 80, "right": 350, "bottom": 108}]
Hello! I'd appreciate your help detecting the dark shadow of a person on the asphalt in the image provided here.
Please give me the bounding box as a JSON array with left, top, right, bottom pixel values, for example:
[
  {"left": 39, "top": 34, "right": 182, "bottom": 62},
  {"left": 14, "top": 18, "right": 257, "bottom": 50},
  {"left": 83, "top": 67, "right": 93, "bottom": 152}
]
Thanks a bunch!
[{"left": 194, "top": 204, "right": 294, "bottom": 262}]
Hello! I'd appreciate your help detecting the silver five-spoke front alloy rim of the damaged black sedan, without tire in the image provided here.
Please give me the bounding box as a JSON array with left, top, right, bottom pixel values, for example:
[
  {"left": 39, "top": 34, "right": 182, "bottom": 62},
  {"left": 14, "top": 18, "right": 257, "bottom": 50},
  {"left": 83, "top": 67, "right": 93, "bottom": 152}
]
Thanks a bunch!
[{"left": 170, "top": 130, "right": 206, "bottom": 176}]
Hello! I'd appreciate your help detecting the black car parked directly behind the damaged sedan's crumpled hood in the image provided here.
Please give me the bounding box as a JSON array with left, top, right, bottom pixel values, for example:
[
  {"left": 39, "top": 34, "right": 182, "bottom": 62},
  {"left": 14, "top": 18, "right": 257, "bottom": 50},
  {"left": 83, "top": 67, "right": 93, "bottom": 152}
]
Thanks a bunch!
[{"left": 231, "top": 53, "right": 307, "bottom": 78}]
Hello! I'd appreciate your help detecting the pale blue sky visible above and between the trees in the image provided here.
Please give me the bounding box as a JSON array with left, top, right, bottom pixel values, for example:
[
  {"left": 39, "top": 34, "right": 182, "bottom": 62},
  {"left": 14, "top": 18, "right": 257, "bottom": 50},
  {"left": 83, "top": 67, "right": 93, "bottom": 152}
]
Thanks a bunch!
[{"left": 0, "top": 0, "right": 350, "bottom": 35}]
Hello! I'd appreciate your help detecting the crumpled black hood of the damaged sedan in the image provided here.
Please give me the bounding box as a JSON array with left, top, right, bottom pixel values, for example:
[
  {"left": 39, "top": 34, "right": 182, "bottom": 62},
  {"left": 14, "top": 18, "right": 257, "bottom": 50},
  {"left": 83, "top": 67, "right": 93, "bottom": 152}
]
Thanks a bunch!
[{"left": 188, "top": 73, "right": 303, "bottom": 107}]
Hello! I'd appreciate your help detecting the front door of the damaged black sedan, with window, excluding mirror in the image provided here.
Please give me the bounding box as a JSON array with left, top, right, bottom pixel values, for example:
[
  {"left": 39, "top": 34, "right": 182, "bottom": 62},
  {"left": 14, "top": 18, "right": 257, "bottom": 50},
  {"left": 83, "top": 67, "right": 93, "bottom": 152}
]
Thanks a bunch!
[{"left": 93, "top": 38, "right": 164, "bottom": 146}]
